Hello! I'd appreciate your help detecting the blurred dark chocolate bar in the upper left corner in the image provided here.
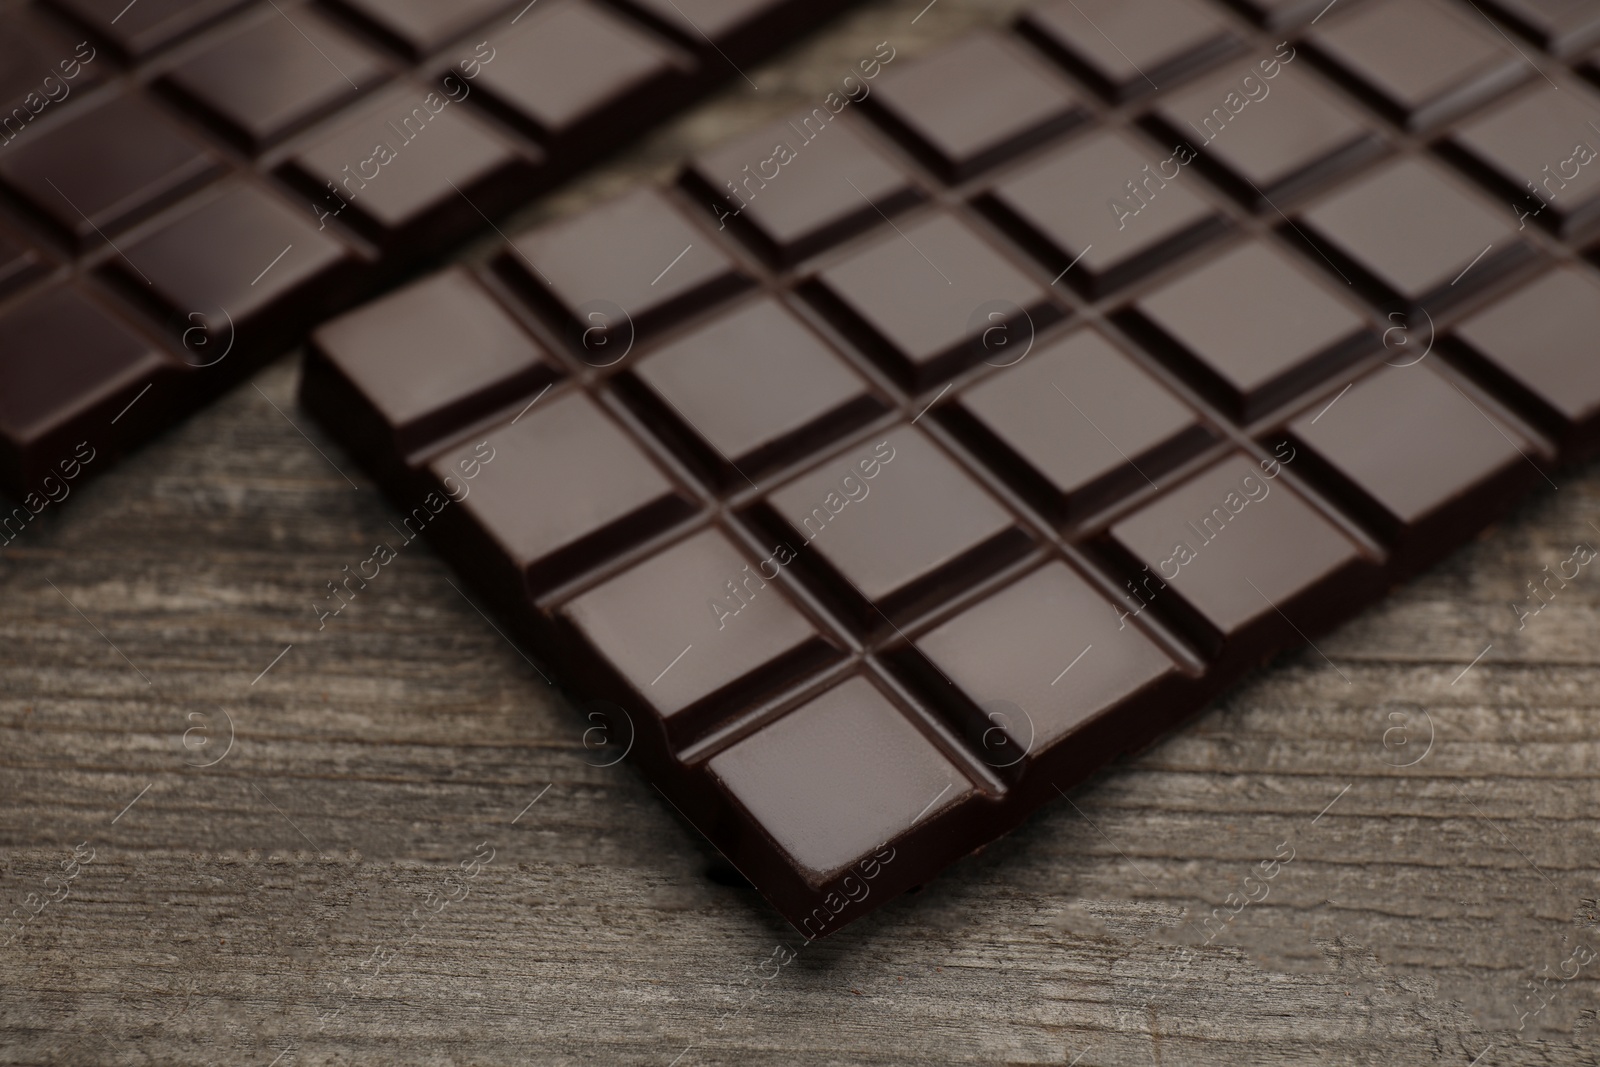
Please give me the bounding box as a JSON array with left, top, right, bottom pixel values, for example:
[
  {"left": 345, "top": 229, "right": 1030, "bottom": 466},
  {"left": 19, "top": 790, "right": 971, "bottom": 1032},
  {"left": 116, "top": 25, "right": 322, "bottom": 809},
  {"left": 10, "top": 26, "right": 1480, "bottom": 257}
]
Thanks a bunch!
[{"left": 0, "top": 0, "right": 848, "bottom": 499}]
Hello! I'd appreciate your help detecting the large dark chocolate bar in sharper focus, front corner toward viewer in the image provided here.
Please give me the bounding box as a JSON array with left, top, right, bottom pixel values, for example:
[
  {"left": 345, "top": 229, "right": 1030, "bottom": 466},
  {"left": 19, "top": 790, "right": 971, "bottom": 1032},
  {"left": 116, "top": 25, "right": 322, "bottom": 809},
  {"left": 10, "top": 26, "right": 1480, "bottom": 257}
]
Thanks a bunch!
[{"left": 301, "top": 0, "right": 1600, "bottom": 937}]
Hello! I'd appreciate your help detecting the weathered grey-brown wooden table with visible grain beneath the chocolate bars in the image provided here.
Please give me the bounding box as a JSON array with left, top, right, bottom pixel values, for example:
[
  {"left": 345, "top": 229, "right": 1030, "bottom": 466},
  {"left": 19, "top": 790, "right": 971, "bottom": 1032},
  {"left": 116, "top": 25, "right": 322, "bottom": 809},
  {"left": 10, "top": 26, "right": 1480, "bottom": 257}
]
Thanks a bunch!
[{"left": 0, "top": 0, "right": 1600, "bottom": 1067}]
